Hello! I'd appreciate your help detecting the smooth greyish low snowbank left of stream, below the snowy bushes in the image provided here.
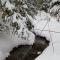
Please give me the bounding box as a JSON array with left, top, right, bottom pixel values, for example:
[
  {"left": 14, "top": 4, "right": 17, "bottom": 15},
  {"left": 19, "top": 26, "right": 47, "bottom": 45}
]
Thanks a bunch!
[{"left": 0, "top": 29, "right": 35, "bottom": 60}]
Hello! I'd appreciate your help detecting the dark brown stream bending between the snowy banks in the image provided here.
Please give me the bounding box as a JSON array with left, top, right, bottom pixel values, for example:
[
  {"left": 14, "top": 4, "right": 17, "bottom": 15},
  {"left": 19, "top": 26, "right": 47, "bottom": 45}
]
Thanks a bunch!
[{"left": 5, "top": 35, "right": 49, "bottom": 60}]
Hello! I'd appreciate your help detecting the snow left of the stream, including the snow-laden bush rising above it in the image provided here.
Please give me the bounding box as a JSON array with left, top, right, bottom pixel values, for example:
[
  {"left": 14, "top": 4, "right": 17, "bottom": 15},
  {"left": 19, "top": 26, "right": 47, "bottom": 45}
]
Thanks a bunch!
[{"left": 0, "top": 12, "right": 35, "bottom": 60}]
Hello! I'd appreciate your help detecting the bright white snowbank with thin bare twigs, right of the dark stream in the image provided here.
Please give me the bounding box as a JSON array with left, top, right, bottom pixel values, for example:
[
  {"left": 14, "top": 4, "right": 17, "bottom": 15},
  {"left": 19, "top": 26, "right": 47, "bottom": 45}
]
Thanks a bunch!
[{"left": 34, "top": 11, "right": 60, "bottom": 60}]
